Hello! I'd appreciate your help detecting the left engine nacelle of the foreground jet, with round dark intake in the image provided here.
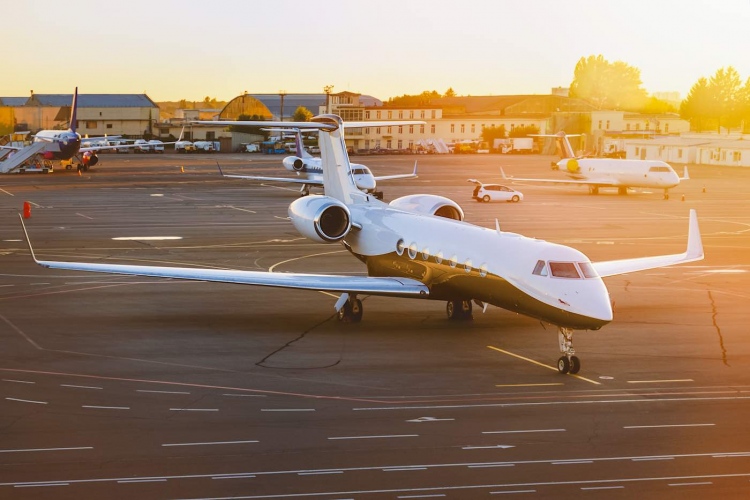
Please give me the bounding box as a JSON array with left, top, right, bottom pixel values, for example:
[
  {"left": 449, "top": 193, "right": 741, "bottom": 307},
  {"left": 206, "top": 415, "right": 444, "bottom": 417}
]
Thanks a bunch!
[{"left": 289, "top": 194, "right": 352, "bottom": 243}]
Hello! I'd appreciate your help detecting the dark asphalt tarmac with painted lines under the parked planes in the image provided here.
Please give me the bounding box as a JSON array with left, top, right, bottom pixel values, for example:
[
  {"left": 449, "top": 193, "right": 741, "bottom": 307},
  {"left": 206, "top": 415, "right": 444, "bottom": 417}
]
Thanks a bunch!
[{"left": 0, "top": 154, "right": 750, "bottom": 500}]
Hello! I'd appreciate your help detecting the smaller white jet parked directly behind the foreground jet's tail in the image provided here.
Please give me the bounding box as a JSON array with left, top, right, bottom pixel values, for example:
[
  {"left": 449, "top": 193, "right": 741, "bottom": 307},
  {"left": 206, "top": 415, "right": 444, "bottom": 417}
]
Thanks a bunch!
[{"left": 214, "top": 126, "right": 417, "bottom": 199}]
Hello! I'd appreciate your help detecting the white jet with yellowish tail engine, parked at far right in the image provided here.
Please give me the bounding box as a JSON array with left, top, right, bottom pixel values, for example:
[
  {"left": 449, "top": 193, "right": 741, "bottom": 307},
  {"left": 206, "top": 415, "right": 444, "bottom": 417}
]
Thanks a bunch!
[{"left": 500, "top": 132, "right": 690, "bottom": 200}]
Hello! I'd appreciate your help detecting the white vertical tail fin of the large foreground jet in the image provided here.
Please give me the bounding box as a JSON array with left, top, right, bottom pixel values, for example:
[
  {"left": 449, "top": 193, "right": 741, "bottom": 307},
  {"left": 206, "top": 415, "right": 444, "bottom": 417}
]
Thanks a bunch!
[{"left": 312, "top": 115, "right": 367, "bottom": 205}]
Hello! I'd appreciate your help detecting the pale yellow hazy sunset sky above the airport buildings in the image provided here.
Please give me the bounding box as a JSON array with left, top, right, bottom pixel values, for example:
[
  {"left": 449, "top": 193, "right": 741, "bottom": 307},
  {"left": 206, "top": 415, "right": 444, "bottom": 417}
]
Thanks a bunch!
[{"left": 0, "top": 0, "right": 750, "bottom": 101}]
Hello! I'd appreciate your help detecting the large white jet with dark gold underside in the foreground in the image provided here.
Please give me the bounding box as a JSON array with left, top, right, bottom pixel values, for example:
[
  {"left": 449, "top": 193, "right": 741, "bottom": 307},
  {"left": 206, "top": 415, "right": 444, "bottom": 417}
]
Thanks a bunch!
[{"left": 19, "top": 115, "right": 703, "bottom": 373}]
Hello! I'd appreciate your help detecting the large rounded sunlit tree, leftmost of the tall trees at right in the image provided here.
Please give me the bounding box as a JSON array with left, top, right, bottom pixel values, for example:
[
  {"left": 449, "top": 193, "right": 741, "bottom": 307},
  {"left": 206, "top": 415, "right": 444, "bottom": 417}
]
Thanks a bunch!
[{"left": 570, "top": 54, "right": 647, "bottom": 111}]
